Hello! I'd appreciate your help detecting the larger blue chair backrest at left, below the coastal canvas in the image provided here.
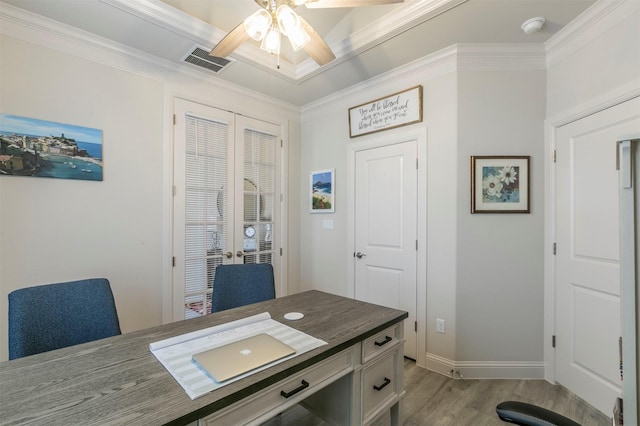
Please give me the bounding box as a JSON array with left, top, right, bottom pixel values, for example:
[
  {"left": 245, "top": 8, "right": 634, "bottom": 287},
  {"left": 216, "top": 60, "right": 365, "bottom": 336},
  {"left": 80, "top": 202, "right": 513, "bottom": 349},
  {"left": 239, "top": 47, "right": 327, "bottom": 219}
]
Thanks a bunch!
[{"left": 9, "top": 278, "right": 120, "bottom": 359}]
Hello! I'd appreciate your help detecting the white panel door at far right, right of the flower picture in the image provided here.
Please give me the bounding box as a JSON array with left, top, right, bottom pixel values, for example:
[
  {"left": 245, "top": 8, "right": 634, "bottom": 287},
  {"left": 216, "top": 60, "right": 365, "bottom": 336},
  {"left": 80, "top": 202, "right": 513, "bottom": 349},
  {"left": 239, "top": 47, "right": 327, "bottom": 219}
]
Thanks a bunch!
[{"left": 555, "top": 99, "right": 640, "bottom": 414}]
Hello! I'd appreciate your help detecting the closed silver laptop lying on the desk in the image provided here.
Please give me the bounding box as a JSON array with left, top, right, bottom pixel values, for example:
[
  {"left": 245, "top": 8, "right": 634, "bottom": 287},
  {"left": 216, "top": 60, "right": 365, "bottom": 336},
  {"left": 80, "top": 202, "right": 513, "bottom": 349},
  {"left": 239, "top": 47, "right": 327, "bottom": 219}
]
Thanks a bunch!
[{"left": 191, "top": 333, "right": 296, "bottom": 383}]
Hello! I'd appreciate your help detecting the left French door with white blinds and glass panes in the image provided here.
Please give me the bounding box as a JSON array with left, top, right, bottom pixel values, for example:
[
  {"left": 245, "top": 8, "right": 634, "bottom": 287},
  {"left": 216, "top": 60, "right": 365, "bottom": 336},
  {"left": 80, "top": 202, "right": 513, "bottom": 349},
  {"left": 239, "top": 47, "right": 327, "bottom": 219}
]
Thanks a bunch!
[{"left": 173, "top": 99, "right": 234, "bottom": 319}]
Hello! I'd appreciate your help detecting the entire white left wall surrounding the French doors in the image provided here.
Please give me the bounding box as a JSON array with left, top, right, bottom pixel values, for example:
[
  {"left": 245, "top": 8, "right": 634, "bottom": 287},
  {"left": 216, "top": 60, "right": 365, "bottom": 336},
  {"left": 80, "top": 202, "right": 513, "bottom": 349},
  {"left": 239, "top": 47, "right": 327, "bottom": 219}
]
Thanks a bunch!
[{"left": 0, "top": 22, "right": 300, "bottom": 359}]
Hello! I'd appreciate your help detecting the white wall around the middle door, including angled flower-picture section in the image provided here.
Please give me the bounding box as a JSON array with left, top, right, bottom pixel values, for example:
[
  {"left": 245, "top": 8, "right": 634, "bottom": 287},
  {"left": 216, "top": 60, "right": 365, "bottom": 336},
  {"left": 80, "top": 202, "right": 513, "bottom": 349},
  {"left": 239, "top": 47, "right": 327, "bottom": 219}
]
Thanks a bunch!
[{"left": 300, "top": 46, "right": 545, "bottom": 377}]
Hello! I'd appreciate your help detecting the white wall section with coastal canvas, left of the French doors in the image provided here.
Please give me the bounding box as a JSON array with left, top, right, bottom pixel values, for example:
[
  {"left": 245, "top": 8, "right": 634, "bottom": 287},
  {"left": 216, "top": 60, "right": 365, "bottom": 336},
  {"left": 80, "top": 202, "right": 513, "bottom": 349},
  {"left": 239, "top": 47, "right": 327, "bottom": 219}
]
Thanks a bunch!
[{"left": 0, "top": 37, "right": 162, "bottom": 356}]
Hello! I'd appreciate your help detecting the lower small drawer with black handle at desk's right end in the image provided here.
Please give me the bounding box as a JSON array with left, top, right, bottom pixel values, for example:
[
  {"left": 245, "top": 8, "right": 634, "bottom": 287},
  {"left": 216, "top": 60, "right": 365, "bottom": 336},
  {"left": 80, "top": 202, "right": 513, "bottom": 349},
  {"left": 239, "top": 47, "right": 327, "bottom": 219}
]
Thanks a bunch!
[{"left": 362, "top": 349, "right": 402, "bottom": 423}]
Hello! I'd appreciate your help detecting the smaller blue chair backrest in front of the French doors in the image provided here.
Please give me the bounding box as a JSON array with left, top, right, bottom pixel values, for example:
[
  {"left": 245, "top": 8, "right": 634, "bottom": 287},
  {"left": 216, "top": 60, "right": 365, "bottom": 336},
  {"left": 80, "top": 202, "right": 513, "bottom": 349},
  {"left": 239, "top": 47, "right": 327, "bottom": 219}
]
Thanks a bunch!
[{"left": 211, "top": 263, "right": 276, "bottom": 312}]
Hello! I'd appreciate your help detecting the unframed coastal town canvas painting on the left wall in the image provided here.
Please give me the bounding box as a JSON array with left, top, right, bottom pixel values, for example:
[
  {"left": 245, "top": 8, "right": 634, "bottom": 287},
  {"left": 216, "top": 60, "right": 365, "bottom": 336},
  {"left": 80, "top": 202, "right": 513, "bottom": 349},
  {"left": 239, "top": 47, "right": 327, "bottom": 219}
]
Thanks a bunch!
[{"left": 0, "top": 114, "right": 102, "bottom": 181}]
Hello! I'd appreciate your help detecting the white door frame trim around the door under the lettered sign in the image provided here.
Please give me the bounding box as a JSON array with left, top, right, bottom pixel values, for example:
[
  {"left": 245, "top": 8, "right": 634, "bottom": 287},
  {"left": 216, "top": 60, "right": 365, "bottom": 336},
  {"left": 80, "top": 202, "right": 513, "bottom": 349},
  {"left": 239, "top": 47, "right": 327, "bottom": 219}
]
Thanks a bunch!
[{"left": 346, "top": 126, "right": 428, "bottom": 368}]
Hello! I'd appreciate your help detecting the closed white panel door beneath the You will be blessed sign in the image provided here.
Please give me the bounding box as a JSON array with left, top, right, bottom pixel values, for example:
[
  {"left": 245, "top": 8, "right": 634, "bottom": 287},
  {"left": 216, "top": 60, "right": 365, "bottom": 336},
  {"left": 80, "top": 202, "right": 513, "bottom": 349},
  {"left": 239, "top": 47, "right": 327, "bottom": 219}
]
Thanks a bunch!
[{"left": 354, "top": 140, "right": 418, "bottom": 359}]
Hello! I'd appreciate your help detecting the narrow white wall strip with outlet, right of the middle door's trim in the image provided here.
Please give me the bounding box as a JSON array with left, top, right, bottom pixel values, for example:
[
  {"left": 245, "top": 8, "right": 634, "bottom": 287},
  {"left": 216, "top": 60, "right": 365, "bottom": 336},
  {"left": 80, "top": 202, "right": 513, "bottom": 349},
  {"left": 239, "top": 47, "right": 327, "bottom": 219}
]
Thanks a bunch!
[{"left": 421, "top": 72, "right": 460, "bottom": 364}]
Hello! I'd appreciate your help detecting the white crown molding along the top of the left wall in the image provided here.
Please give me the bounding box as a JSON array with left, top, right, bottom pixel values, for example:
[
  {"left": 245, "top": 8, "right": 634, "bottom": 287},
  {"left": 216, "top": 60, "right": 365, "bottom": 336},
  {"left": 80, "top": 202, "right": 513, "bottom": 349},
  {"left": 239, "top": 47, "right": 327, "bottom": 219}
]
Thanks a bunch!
[{"left": 0, "top": 2, "right": 299, "bottom": 113}]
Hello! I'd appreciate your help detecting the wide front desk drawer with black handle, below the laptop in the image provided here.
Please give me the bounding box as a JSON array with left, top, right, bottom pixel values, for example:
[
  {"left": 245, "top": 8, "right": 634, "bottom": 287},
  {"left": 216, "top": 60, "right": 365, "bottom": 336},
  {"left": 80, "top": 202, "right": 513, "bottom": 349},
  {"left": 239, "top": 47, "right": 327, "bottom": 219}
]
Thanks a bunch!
[{"left": 199, "top": 346, "right": 357, "bottom": 426}]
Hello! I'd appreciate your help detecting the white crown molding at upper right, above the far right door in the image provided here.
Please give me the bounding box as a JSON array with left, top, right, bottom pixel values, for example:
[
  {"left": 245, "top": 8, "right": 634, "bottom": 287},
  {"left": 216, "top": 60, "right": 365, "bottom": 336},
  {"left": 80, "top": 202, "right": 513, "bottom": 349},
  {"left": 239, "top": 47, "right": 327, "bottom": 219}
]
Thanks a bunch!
[{"left": 545, "top": 0, "right": 640, "bottom": 68}]
